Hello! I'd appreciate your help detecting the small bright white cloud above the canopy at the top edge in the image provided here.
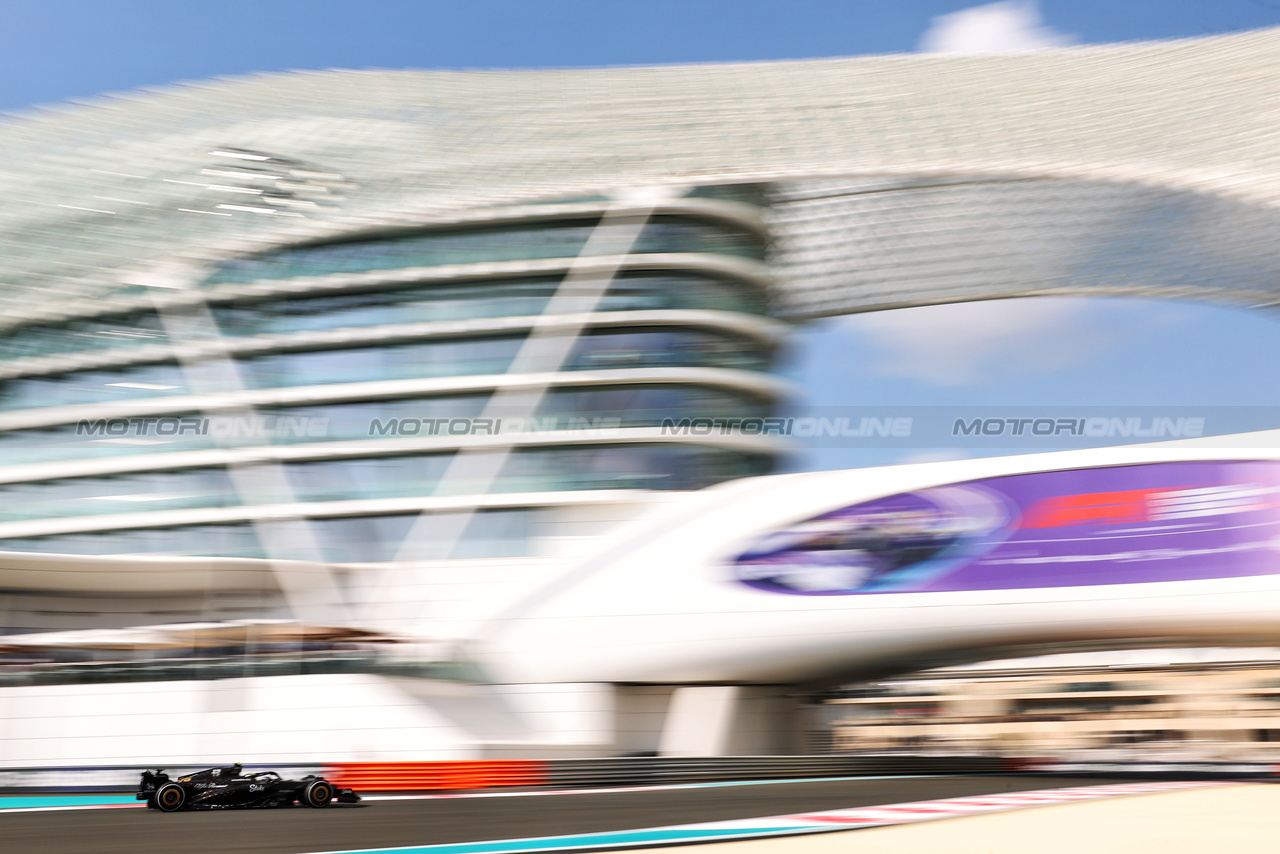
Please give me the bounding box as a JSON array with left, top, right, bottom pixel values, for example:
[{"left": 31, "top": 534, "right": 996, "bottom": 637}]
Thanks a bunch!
[{"left": 919, "top": 0, "right": 1075, "bottom": 54}]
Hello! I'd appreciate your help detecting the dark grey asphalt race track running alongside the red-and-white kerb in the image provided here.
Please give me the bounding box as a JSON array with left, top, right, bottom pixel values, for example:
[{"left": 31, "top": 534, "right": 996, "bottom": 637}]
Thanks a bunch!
[{"left": 0, "top": 776, "right": 1103, "bottom": 854}]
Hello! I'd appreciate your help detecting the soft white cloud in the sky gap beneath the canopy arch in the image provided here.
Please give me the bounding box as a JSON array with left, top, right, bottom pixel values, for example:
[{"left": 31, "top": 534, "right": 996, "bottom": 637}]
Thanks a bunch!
[{"left": 837, "top": 297, "right": 1114, "bottom": 385}]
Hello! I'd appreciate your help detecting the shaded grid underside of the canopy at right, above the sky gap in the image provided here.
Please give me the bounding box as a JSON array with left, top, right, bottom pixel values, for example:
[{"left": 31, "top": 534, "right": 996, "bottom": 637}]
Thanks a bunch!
[{"left": 771, "top": 177, "right": 1280, "bottom": 318}]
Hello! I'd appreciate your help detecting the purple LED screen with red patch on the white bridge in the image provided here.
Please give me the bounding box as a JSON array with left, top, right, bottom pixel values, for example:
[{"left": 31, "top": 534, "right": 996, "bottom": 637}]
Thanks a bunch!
[{"left": 733, "top": 461, "right": 1280, "bottom": 595}]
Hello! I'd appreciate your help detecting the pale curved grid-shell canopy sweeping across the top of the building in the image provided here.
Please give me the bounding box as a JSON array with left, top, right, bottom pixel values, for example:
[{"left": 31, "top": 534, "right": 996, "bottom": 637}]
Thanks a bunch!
[{"left": 0, "top": 29, "right": 1280, "bottom": 319}]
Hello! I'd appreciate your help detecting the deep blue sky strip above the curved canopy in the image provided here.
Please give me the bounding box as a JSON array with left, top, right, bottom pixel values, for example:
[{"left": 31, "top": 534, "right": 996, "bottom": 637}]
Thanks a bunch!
[{"left": 0, "top": 0, "right": 1280, "bottom": 110}]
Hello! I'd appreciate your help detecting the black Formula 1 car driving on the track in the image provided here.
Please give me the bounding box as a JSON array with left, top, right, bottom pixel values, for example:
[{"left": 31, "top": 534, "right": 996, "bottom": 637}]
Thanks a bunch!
[{"left": 136, "top": 764, "right": 360, "bottom": 813}]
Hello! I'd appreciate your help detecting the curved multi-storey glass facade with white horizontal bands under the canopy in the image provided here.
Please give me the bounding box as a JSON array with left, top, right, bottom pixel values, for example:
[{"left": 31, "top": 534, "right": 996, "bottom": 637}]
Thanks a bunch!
[{"left": 0, "top": 197, "right": 773, "bottom": 562}]
